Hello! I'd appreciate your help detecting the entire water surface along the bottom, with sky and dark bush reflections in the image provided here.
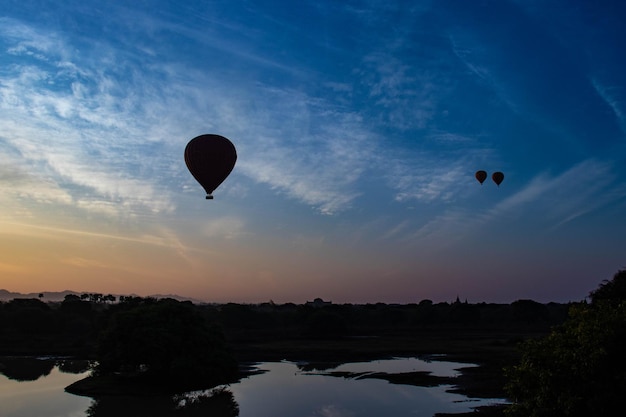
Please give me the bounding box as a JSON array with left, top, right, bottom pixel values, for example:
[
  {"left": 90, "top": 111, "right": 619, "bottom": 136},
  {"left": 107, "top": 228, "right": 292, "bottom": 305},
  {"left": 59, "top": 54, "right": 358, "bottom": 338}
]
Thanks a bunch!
[{"left": 0, "top": 358, "right": 504, "bottom": 417}]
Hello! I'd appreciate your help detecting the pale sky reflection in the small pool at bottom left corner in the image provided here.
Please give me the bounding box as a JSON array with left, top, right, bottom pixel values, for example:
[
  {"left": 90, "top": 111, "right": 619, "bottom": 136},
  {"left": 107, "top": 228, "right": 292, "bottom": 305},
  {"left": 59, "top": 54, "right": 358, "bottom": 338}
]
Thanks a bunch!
[{"left": 0, "top": 367, "right": 92, "bottom": 417}]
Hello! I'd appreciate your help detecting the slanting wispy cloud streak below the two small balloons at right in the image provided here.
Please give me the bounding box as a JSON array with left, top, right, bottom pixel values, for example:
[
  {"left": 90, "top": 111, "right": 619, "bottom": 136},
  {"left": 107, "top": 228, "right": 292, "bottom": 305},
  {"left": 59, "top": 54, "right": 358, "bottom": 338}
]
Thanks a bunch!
[{"left": 390, "top": 159, "right": 626, "bottom": 250}]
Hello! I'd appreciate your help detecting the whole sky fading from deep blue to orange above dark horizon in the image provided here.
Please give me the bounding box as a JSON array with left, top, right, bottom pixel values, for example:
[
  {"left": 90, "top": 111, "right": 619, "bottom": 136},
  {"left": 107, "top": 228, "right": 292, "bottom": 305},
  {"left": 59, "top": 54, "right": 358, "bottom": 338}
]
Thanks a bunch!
[{"left": 0, "top": 0, "right": 626, "bottom": 303}]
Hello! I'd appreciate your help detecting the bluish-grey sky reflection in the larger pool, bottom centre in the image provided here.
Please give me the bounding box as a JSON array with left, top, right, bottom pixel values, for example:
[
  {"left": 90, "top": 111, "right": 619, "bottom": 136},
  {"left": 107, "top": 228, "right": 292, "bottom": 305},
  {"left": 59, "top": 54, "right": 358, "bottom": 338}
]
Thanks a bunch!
[{"left": 230, "top": 360, "right": 502, "bottom": 417}]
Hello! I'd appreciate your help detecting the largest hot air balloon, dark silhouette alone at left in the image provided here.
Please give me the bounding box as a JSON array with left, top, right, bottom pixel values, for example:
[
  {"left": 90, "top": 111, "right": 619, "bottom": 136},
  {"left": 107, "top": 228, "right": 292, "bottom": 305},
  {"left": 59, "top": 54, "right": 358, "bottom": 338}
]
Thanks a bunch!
[{"left": 185, "top": 135, "right": 237, "bottom": 200}]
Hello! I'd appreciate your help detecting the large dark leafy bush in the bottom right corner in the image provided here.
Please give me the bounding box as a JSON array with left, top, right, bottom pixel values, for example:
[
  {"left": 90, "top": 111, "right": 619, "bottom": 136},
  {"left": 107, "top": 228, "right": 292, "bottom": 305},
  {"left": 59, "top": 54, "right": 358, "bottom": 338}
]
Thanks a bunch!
[{"left": 506, "top": 271, "right": 626, "bottom": 417}]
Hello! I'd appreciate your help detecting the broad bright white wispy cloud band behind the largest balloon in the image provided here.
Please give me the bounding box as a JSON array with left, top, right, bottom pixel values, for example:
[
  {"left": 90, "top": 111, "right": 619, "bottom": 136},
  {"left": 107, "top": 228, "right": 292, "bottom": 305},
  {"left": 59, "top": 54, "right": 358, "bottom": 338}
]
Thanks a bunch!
[{"left": 0, "top": 13, "right": 400, "bottom": 214}]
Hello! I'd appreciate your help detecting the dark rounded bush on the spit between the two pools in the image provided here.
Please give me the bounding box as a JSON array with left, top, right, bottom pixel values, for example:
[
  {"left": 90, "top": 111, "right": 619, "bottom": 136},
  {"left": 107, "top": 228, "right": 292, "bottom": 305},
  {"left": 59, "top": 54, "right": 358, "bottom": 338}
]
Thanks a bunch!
[{"left": 96, "top": 299, "right": 237, "bottom": 388}]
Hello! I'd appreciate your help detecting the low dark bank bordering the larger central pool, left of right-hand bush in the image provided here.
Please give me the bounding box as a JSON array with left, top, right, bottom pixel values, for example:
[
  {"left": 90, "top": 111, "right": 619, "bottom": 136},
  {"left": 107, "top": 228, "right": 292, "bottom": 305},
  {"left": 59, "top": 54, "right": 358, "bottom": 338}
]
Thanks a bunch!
[{"left": 228, "top": 328, "right": 544, "bottom": 417}]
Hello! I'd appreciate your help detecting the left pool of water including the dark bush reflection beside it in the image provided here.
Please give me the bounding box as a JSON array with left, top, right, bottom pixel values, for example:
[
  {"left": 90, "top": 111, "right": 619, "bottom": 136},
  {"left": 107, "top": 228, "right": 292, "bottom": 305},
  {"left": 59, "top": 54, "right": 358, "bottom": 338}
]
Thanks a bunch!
[{"left": 0, "top": 357, "right": 239, "bottom": 417}]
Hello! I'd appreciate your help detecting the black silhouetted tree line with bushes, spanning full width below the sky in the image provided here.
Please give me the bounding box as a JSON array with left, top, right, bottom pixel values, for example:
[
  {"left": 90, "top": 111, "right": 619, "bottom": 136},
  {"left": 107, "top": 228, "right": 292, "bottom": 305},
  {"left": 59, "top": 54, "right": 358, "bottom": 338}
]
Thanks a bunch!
[{"left": 0, "top": 270, "right": 626, "bottom": 417}]
